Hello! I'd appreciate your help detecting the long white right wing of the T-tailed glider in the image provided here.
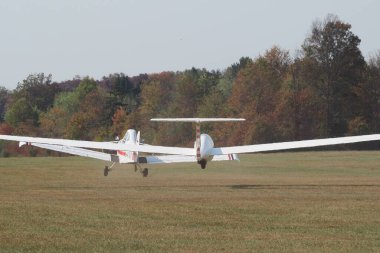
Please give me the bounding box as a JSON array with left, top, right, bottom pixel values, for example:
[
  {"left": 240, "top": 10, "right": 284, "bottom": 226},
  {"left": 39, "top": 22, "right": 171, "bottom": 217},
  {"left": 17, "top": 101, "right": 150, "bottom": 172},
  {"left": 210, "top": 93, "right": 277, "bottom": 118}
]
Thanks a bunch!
[{"left": 211, "top": 134, "right": 380, "bottom": 155}]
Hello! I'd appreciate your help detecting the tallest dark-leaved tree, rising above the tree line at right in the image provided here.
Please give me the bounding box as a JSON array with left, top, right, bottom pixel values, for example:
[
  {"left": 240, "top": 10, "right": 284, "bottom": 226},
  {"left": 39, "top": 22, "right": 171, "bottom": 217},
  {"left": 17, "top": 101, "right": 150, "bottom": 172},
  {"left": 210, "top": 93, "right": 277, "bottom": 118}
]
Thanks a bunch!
[{"left": 302, "top": 15, "right": 365, "bottom": 137}]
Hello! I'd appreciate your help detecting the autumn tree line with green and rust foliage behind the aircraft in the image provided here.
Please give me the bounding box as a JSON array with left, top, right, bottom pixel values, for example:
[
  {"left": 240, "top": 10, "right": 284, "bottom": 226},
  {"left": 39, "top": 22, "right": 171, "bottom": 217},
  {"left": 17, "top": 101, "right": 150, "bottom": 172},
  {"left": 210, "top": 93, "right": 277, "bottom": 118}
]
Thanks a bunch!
[{"left": 0, "top": 15, "right": 380, "bottom": 156}]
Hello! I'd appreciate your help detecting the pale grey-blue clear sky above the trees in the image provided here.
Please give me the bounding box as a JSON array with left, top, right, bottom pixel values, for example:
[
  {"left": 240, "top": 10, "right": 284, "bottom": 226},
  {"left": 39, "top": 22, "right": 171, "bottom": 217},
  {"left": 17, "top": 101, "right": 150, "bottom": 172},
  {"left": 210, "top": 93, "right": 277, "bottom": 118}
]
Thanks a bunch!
[{"left": 0, "top": 0, "right": 380, "bottom": 90}]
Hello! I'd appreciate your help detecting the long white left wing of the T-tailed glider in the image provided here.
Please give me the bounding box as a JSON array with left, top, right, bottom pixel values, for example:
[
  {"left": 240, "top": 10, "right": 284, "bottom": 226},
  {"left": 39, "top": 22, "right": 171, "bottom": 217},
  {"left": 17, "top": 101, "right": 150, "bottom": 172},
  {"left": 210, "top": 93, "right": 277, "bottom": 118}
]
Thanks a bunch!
[{"left": 0, "top": 135, "right": 195, "bottom": 155}]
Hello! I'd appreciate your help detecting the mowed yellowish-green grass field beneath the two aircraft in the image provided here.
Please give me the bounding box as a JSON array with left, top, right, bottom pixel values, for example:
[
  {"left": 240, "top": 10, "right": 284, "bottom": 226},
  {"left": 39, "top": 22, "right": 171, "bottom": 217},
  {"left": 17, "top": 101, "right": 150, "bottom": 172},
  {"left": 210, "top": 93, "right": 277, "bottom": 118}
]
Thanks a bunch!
[{"left": 0, "top": 152, "right": 380, "bottom": 252}]
